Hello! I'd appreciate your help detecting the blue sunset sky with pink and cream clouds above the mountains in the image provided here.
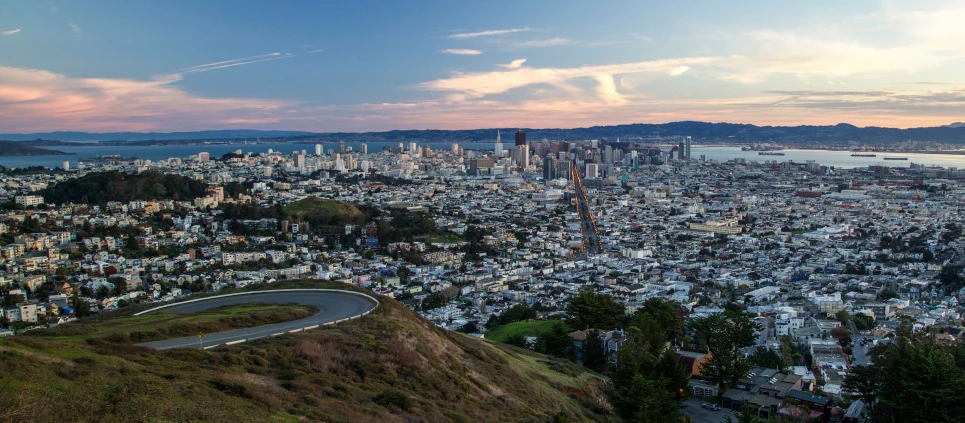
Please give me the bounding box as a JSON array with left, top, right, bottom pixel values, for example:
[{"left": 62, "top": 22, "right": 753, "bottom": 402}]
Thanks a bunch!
[{"left": 0, "top": 0, "right": 965, "bottom": 133}]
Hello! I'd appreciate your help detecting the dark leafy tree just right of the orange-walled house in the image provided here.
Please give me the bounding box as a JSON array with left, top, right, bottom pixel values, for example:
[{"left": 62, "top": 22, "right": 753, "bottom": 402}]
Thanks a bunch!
[{"left": 690, "top": 310, "right": 759, "bottom": 387}]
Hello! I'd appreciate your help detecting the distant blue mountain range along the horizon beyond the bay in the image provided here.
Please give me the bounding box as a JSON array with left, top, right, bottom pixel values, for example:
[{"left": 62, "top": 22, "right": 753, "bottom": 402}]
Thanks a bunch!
[{"left": 0, "top": 121, "right": 965, "bottom": 147}]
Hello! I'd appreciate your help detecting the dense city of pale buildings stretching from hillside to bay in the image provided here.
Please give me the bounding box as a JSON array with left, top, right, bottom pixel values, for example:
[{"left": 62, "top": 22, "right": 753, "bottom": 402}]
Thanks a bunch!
[{"left": 0, "top": 135, "right": 965, "bottom": 422}]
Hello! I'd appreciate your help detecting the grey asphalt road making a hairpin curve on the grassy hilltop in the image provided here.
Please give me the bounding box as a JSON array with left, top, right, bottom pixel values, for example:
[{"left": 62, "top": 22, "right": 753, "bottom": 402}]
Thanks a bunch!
[{"left": 138, "top": 290, "right": 378, "bottom": 350}]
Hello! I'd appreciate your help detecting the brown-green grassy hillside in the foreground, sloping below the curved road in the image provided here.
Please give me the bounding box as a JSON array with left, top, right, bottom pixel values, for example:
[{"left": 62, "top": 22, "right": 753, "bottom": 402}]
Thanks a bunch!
[{"left": 0, "top": 282, "right": 614, "bottom": 422}]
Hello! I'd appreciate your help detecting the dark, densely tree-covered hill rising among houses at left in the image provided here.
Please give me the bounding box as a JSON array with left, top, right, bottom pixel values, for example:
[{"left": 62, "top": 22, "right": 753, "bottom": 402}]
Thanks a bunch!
[{"left": 40, "top": 171, "right": 207, "bottom": 204}]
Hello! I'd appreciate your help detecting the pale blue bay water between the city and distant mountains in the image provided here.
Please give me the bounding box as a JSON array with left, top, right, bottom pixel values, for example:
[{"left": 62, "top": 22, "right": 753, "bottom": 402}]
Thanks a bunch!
[{"left": 0, "top": 141, "right": 965, "bottom": 168}]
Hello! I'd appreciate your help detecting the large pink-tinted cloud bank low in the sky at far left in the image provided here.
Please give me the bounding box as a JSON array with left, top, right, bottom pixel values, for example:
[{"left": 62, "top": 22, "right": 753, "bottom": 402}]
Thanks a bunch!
[{"left": 0, "top": 66, "right": 296, "bottom": 132}]
